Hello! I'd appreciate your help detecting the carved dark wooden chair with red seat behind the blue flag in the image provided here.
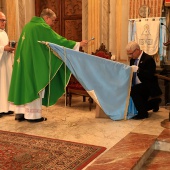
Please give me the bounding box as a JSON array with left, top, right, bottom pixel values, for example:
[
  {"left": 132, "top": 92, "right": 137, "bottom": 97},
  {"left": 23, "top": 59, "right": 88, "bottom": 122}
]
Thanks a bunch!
[{"left": 66, "top": 43, "right": 112, "bottom": 111}]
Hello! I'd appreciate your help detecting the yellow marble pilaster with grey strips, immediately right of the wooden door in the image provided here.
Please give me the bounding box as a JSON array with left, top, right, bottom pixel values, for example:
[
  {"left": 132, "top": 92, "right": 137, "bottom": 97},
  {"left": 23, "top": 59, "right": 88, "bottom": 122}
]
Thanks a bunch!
[{"left": 82, "top": 0, "right": 110, "bottom": 54}]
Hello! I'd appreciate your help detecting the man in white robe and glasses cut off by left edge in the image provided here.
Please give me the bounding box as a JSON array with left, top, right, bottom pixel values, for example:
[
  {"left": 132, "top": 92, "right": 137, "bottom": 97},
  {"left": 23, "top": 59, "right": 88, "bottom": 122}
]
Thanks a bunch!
[{"left": 0, "top": 12, "right": 14, "bottom": 117}]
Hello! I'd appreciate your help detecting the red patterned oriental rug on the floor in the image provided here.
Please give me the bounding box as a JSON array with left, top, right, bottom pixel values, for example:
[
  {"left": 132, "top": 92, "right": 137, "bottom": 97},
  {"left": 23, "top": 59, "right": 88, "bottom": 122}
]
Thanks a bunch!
[{"left": 0, "top": 131, "right": 106, "bottom": 170}]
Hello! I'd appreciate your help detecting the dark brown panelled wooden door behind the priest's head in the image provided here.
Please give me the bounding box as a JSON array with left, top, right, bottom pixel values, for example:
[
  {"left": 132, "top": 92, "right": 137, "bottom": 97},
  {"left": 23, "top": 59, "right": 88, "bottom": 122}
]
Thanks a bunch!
[{"left": 35, "top": 0, "right": 82, "bottom": 41}]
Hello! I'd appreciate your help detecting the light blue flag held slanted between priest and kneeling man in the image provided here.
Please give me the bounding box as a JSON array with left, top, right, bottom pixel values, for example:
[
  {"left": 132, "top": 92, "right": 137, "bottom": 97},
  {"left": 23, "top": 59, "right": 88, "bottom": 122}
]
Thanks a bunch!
[{"left": 48, "top": 43, "right": 132, "bottom": 120}]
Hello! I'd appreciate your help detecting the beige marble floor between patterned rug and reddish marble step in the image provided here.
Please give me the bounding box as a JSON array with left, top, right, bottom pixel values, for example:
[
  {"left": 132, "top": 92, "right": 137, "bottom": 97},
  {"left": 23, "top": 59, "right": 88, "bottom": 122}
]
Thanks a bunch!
[{"left": 0, "top": 96, "right": 169, "bottom": 170}]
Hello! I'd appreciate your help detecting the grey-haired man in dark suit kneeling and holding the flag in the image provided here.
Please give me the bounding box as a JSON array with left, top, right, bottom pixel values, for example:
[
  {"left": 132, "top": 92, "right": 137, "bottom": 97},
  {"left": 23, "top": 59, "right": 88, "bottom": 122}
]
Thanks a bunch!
[{"left": 126, "top": 41, "right": 162, "bottom": 119}]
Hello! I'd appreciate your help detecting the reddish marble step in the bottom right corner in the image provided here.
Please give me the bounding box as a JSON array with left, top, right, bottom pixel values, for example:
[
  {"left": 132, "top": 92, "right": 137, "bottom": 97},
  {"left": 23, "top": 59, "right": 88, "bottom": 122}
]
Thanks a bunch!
[{"left": 86, "top": 129, "right": 170, "bottom": 170}]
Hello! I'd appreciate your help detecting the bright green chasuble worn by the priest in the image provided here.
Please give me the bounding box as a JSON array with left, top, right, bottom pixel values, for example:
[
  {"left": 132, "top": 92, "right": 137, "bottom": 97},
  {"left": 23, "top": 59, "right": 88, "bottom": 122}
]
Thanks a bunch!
[{"left": 8, "top": 17, "right": 76, "bottom": 106}]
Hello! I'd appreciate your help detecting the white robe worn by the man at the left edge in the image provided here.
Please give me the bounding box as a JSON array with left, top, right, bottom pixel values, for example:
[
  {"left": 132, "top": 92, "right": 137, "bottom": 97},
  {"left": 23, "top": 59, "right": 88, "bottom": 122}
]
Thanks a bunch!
[{"left": 0, "top": 29, "right": 14, "bottom": 112}]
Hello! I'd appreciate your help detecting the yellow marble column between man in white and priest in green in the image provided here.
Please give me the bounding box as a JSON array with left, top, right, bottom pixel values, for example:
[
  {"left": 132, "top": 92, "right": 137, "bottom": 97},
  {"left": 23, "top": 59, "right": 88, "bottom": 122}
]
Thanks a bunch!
[{"left": 2, "top": 0, "right": 35, "bottom": 41}]
